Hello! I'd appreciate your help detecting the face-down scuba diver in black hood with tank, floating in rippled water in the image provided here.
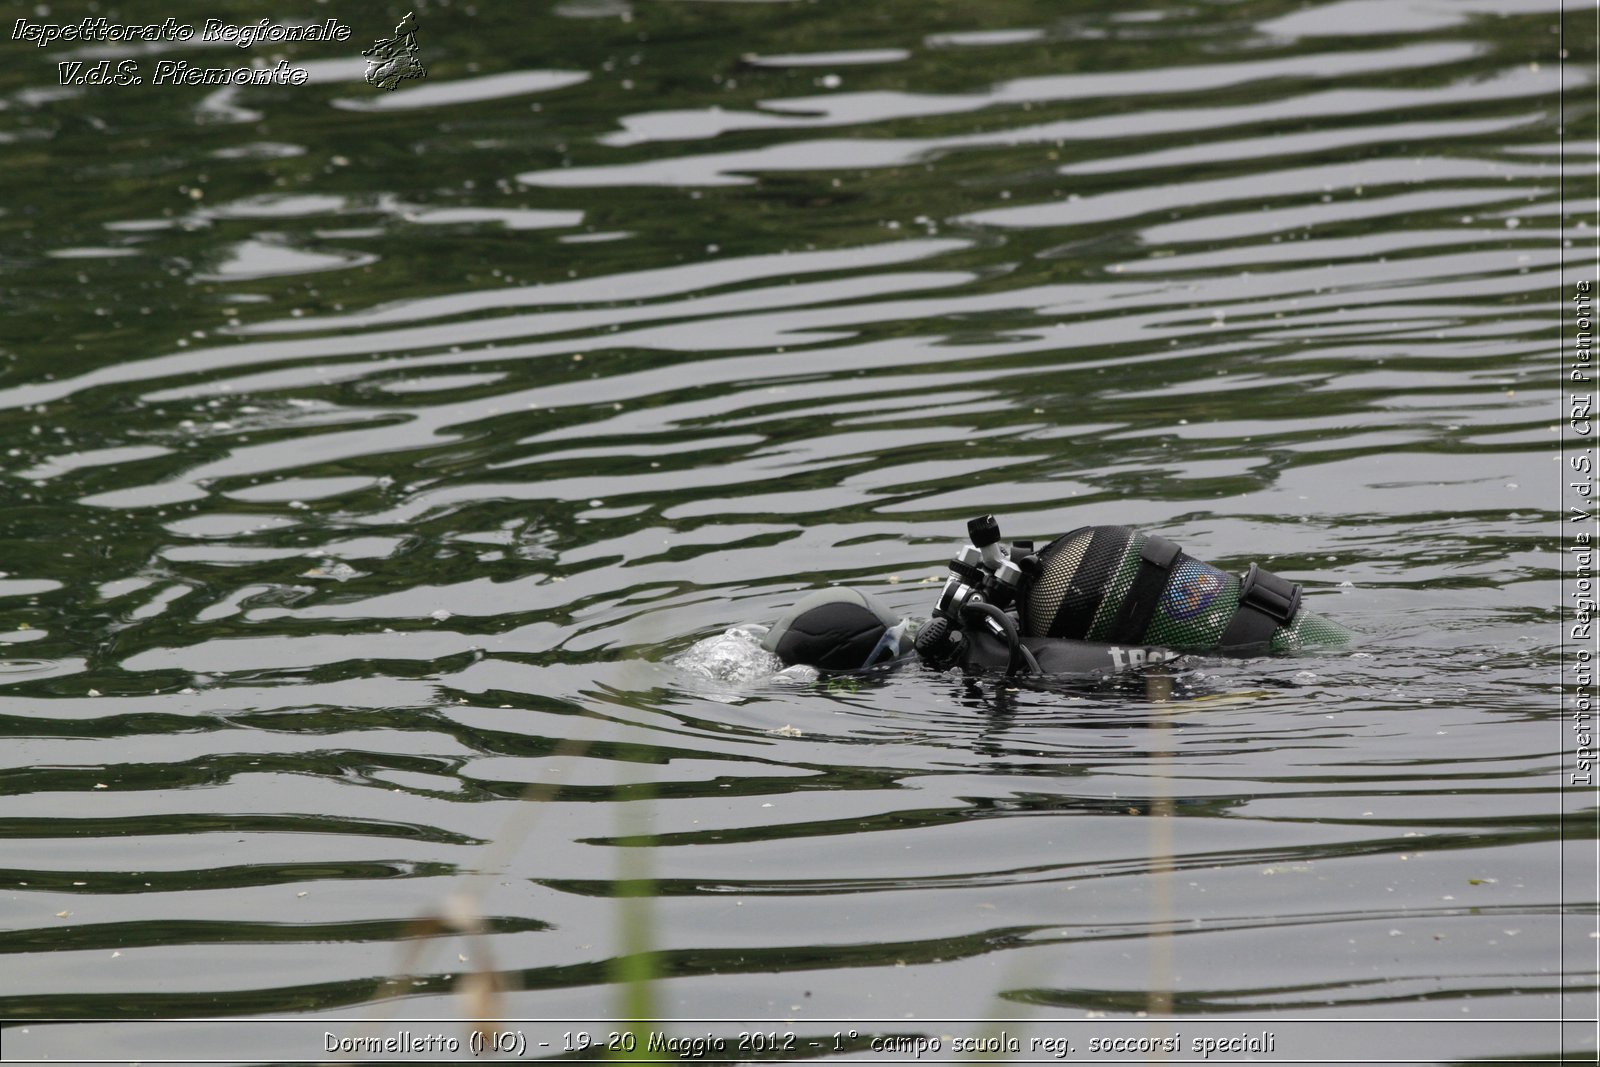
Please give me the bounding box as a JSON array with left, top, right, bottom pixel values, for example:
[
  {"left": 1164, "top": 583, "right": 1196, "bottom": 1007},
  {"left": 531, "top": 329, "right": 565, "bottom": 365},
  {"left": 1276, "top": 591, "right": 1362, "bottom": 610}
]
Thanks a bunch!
[{"left": 762, "top": 515, "right": 1350, "bottom": 677}]
